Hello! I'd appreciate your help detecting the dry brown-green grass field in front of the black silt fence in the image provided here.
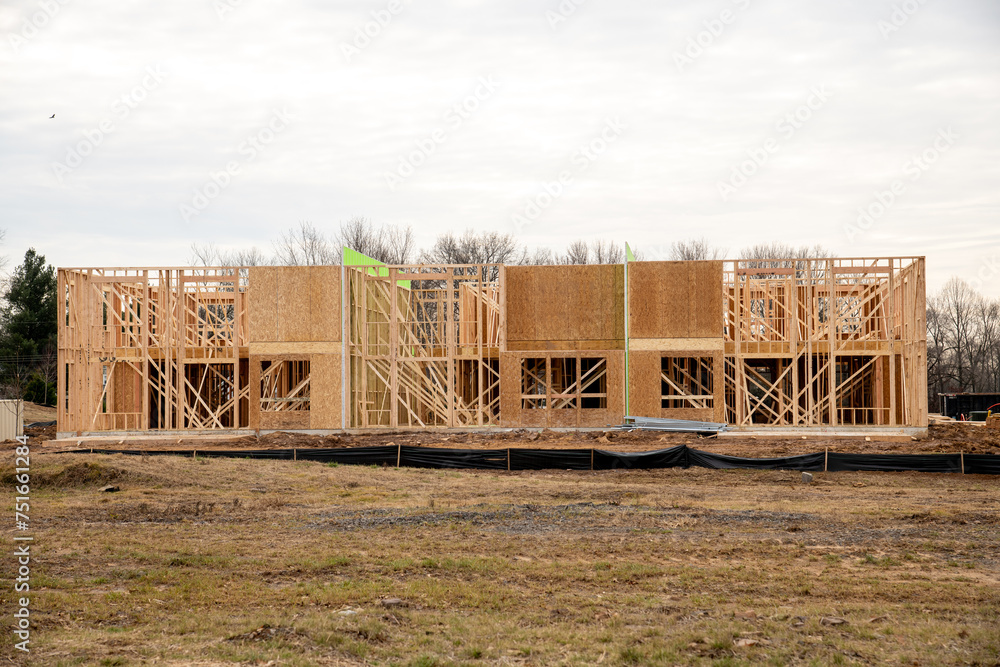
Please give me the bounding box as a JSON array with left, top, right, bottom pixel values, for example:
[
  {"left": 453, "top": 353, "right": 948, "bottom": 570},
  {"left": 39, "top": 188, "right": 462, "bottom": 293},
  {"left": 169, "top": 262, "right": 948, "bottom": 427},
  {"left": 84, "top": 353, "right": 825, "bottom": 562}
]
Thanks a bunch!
[{"left": 0, "top": 453, "right": 1000, "bottom": 666}]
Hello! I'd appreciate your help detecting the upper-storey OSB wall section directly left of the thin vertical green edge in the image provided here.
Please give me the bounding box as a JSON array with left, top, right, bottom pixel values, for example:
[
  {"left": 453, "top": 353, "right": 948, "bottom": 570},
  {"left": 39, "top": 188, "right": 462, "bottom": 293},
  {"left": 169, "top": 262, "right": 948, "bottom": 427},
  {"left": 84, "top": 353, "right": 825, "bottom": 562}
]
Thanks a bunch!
[{"left": 506, "top": 264, "right": 625, "bottom": 341}]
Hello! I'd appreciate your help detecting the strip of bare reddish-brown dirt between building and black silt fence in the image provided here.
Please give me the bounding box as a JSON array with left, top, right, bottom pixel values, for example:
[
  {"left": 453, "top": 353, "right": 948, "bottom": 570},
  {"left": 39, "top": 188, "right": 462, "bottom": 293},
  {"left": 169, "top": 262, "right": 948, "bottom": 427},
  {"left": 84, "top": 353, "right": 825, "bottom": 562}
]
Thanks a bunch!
[{"left": 19, "top": 423, "right": 1000, "bottom": 458}]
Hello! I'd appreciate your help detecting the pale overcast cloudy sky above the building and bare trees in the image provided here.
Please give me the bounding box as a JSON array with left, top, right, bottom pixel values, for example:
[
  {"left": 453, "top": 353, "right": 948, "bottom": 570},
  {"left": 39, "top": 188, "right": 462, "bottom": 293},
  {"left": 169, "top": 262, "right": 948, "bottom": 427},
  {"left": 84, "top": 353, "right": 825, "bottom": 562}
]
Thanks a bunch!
[{"left": 0, "top": 0, "right": 1000, "bottom": 296}]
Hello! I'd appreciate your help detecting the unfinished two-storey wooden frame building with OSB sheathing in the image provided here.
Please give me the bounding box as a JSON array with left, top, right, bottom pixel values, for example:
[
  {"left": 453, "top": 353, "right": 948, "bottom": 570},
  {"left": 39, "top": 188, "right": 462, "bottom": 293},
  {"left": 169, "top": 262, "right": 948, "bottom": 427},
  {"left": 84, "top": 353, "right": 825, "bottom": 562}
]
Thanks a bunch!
[{"left": 58, "top": 257, "right": 927, "bottom": 436}]
